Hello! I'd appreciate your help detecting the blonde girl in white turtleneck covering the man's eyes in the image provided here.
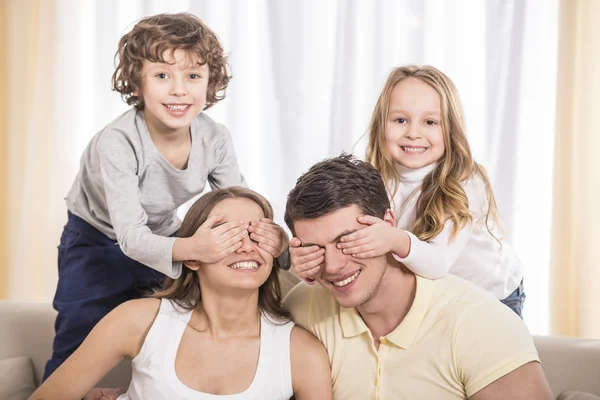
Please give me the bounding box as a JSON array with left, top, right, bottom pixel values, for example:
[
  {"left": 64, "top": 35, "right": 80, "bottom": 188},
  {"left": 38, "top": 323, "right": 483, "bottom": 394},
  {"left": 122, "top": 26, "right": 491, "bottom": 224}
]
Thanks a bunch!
[{"left": 290, "top": 65, "right": 525, "bottom": 315}]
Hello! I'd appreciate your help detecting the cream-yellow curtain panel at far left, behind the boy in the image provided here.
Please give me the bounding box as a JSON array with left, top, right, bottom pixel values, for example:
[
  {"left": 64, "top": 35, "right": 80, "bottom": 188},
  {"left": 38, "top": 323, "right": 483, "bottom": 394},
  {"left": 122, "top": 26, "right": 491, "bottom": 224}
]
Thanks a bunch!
[{"left": 3, "top": 0, "right": 65, "bottom": 300}]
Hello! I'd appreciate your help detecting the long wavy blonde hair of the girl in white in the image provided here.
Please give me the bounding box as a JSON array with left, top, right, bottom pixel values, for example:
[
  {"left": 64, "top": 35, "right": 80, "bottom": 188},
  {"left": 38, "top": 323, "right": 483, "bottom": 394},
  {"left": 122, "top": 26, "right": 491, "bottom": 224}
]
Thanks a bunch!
[{"left": 366, "top": 65, "right": 500, "bottom": 241}]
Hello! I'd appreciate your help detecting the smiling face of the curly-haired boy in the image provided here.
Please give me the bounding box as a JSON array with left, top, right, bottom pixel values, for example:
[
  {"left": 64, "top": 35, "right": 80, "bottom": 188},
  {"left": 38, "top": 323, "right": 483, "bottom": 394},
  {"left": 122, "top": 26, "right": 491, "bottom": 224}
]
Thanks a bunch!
[{"left": 134, "top": 50, "right": 209, "bottom": 135}]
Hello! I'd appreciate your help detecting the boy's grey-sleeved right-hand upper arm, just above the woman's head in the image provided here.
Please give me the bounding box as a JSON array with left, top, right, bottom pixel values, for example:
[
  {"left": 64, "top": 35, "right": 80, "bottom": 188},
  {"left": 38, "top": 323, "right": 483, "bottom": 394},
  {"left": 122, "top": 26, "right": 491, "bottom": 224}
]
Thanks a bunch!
[{"left": 208, "top": 124, "right": 248, "bottom": 189}]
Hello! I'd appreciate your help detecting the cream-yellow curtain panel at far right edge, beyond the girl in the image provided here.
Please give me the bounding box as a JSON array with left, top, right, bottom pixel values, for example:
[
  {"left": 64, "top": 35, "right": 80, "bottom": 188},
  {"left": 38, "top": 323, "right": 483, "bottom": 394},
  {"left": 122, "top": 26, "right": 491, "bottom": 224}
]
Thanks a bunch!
[{"left": 552, "top": 0, "right": 600, "bottom": 338}]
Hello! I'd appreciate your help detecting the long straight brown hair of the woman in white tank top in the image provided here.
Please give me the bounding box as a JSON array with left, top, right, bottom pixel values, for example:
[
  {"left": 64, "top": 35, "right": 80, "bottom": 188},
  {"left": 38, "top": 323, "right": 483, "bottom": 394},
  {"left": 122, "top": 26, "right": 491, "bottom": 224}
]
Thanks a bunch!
[{"left": 153, "top": 186, "right": 290, "bottom": 320}]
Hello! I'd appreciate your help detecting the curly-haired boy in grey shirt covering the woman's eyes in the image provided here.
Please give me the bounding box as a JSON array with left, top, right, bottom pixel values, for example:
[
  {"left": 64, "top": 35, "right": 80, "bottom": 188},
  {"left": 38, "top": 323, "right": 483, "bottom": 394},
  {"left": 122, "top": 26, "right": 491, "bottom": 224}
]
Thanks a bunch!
[{"left": 44, "top": 14, "right": 287, "bottom": 379}]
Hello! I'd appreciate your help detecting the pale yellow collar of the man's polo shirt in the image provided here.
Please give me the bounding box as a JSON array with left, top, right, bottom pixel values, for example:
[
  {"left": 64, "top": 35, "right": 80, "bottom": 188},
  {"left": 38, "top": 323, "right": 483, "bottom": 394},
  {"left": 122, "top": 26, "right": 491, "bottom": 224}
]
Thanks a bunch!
[{"left": 340, "top": 275, "right": 433, "bottom": 349}]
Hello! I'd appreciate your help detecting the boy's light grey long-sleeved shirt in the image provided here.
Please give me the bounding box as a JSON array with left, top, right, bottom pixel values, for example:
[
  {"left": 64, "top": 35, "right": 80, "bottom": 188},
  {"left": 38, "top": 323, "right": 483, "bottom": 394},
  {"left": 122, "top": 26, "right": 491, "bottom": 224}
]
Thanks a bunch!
[{"left": 66, "top": 109, "right": 247, "bottom": 278}]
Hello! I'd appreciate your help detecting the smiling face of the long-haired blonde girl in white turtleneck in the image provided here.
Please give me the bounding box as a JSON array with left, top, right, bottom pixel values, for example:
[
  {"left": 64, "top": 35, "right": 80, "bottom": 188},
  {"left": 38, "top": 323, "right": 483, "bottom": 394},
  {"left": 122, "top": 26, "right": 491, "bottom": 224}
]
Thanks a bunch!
[{"left": 385, "top": 78, "right": 445, "bottom": 169}]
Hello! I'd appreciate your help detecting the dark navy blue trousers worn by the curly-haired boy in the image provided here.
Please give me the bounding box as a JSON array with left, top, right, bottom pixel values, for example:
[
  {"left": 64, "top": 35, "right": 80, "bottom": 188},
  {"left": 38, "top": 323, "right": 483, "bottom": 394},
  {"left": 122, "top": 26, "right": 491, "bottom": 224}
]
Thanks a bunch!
[{"left": 44, "top": 212, "right": 164, "bottom": 380}]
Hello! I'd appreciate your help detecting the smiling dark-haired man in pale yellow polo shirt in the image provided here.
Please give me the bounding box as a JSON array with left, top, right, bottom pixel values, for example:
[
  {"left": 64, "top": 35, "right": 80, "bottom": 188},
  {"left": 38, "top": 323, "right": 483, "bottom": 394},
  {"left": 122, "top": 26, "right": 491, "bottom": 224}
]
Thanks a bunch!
[{"left": 284, "top": 156, "right": 552, "bottom": 400}]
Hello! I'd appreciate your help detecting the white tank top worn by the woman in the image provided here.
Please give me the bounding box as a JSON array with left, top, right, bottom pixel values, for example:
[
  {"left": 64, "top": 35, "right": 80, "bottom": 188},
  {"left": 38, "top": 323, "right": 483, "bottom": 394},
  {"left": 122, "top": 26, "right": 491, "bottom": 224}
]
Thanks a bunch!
[{"left": 117, "top": 299, "right": 294, "bottom": 400}]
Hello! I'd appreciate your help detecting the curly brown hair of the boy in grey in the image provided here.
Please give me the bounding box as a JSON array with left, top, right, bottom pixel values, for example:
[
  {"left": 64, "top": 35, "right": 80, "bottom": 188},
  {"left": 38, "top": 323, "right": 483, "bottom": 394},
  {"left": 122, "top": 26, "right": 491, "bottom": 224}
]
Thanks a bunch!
[{"left": 112, "top": 13, "right": 231, "bottom": 110}]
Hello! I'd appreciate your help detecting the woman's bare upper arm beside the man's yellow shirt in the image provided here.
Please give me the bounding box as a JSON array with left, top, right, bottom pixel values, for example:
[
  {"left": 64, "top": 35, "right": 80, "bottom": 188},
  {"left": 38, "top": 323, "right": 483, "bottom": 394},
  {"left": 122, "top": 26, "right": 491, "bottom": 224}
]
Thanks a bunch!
[{"left": 290, "top": 326, "right": 333, "bottom": 400}]
